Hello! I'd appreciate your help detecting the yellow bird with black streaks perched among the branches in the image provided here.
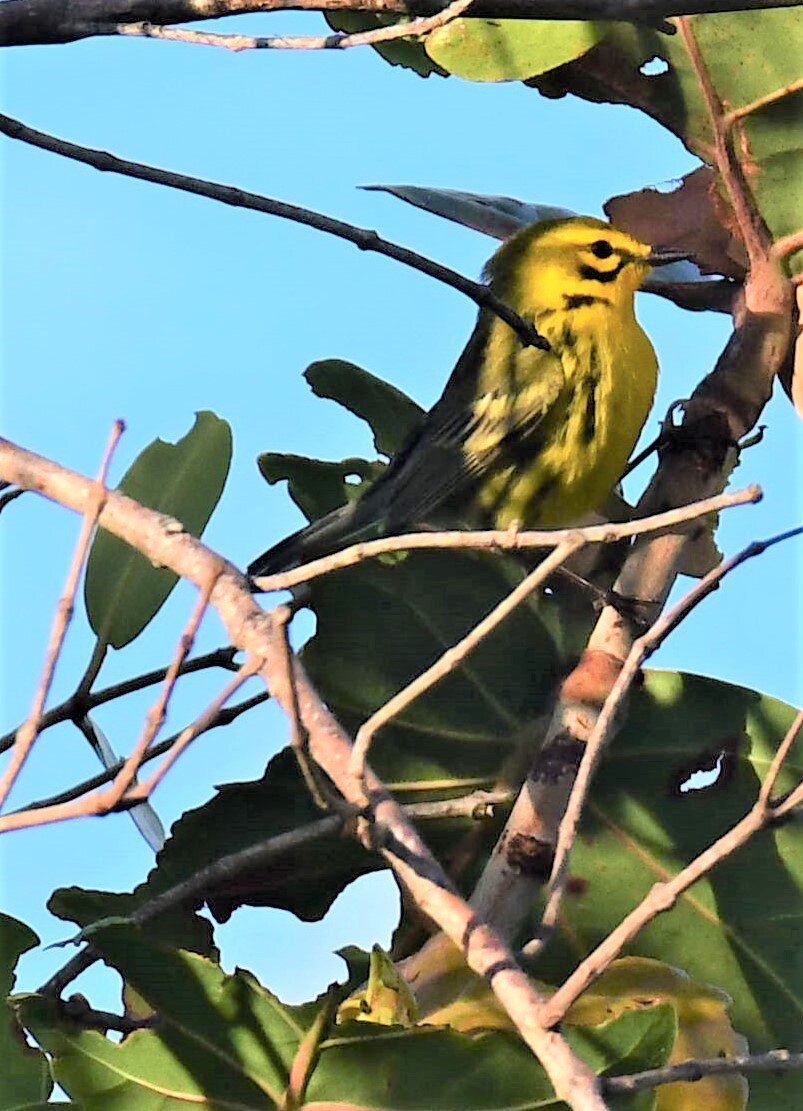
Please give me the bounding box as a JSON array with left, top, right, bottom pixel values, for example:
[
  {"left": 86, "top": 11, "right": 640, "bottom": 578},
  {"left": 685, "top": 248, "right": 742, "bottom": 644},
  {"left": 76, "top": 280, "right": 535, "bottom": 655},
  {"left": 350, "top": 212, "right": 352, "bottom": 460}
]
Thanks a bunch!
[{"left": 249, "top": 217, "right": 682, "bottom": 578}]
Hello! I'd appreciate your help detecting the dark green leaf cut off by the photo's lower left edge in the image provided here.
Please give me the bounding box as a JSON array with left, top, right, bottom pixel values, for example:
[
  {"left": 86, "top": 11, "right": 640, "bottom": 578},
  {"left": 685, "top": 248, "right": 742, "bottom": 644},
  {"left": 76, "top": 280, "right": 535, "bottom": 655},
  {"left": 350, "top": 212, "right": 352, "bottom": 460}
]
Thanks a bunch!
[{"left": 0, "top": 914, "right": 53, "bottom": 1111}]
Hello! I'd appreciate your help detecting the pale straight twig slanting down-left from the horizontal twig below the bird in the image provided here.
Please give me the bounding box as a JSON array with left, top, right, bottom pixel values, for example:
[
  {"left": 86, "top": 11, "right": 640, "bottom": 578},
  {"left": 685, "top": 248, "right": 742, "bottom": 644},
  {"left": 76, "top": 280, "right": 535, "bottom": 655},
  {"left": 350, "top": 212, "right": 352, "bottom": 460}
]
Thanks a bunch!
[{"left": 349, "top": 533, "right": 584, "bottom": 780}]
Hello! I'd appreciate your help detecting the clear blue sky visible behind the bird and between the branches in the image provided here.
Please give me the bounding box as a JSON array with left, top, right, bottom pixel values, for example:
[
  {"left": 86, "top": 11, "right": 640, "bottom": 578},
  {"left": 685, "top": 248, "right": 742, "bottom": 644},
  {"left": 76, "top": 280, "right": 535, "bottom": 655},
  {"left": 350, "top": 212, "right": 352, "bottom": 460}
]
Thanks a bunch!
[{"left": 0, "top": 13, "right": 803, "bottom": 1000}]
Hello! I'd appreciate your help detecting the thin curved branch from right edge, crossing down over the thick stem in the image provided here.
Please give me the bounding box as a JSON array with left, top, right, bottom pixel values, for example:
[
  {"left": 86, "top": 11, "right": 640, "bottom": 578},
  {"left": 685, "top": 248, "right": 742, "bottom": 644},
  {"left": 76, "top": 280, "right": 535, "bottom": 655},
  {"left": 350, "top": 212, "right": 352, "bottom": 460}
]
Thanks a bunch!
[{"left": 524, "top": 527, "right": 803, "bottom": 957}]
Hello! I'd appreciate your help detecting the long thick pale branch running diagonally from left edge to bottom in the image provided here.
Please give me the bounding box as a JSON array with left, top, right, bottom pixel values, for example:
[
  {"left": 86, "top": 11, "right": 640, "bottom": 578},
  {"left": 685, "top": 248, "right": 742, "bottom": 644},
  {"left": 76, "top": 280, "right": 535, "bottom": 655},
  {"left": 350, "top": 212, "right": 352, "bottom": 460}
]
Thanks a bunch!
[{"left": 0, "top": 440, "right": 605, "bottom": 1111}]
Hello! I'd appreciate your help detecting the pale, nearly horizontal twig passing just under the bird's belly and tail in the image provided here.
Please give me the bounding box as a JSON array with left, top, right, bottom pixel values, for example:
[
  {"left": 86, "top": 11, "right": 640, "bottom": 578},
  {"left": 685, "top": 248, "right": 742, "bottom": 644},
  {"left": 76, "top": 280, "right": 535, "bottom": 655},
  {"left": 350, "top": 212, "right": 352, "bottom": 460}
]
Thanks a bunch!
[{"left": 253, "top": 484, "right": 762, "bottom": 592}]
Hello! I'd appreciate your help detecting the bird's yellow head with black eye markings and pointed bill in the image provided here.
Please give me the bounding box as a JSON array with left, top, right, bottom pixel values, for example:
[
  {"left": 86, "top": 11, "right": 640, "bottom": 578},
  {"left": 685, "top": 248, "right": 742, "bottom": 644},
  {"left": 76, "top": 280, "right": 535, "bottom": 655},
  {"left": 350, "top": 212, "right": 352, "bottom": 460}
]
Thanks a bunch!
[{"left": 485, "top": 217, "right": 681, "bottom": 314}]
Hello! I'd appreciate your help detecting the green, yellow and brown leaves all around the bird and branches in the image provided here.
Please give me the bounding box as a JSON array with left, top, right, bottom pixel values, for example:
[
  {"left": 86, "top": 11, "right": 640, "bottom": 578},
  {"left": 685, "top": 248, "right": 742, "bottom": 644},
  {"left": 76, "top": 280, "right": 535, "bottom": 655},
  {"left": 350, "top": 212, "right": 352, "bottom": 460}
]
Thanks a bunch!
[{"left": 0, "top": 2, "right": 803, "bottom": 1111}]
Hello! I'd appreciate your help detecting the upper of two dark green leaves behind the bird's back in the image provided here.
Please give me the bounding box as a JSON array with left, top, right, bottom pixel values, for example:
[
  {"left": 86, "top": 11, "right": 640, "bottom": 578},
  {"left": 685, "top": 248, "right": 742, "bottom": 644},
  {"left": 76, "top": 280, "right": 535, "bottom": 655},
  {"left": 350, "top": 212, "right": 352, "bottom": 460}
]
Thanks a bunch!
[{"left": 304, "top": 359, "right": 425, "bottom": 457}]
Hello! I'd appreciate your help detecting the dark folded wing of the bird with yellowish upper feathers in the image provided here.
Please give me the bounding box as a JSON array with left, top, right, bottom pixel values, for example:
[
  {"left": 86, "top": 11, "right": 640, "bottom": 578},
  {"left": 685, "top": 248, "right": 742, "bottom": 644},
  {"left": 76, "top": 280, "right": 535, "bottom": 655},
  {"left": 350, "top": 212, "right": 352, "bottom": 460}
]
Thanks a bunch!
[{"left": 357, "top": 313, "right": 565, "bottom": 533}]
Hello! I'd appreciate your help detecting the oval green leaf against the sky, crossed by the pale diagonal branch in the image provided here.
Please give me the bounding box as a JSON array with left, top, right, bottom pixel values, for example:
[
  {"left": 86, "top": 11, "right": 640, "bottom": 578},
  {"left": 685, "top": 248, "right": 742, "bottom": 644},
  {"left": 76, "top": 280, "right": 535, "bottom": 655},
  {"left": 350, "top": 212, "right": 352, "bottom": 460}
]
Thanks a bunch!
[{"left": 84, "top": 411, "right": 231, "bottom": 648}]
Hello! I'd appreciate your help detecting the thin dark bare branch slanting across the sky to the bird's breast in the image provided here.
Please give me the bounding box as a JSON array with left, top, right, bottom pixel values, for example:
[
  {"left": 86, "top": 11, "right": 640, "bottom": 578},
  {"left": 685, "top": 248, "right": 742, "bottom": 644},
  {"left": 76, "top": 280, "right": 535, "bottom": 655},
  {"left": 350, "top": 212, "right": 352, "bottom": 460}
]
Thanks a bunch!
[{"left": 0, "top": 112, "right": 550, "bottom": 351}]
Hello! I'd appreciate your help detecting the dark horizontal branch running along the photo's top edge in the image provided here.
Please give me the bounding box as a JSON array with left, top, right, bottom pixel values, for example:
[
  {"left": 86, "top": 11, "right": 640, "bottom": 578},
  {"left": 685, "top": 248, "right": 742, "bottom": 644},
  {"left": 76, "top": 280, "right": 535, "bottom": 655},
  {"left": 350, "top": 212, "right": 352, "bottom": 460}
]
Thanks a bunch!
[{"left": 0, "top": 0, "right": 799, "bottom": 46}]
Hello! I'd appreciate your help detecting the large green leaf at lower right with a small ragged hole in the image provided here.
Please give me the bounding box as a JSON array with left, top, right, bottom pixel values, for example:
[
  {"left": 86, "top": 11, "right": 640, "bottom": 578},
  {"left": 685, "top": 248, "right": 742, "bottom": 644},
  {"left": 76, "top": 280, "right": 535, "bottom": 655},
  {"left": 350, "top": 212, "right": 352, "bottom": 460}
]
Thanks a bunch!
[{"left": 539, "top": 671, "right": 803, "bottom": 1111}]
